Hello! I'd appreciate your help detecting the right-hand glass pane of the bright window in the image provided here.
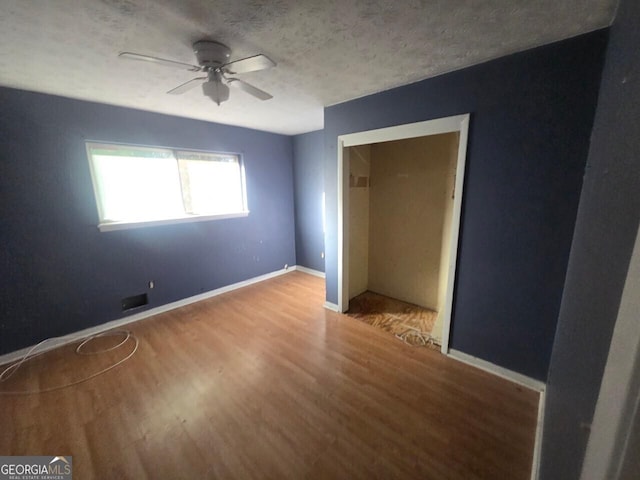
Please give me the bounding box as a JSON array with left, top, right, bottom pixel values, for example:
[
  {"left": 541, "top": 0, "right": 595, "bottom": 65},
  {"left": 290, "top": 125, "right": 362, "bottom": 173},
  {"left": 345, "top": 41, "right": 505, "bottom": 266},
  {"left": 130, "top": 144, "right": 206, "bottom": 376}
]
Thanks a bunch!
[{"left": 178, "top": 152, "right": 244, "bottom": 215}]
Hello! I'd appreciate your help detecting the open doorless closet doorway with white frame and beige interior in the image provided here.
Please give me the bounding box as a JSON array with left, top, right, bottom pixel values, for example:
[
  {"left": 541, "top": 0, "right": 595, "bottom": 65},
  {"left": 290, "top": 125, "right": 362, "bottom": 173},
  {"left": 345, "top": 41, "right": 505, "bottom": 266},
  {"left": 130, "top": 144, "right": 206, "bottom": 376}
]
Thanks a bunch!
[{"left": 338, "top": 115, "right": 469, "bottom": 353}]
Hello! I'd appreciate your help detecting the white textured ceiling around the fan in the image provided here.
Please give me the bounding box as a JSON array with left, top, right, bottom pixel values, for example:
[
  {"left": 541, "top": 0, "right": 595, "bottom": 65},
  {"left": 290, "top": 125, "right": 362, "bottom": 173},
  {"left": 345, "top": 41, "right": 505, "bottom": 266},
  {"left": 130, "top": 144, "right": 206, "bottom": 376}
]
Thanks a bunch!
[{"left": 0, "top": 0, "right": 616, "bottom": 134}]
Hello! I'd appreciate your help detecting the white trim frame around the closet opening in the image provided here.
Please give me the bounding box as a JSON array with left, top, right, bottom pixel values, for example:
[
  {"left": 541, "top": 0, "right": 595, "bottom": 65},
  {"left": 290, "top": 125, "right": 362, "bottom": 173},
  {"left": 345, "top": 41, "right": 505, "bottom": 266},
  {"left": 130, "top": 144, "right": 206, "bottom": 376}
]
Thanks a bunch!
[{"left": 338, "top": 113, "right": 470, "bottom": 354}]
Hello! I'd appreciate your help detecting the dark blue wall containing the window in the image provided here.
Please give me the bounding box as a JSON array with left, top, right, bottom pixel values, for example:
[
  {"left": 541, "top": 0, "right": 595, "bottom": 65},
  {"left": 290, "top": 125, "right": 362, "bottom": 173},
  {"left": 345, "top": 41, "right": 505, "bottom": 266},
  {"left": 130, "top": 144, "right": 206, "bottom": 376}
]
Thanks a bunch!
[{"left": 0, "top": 88, "right": 295, "bottom": 353}]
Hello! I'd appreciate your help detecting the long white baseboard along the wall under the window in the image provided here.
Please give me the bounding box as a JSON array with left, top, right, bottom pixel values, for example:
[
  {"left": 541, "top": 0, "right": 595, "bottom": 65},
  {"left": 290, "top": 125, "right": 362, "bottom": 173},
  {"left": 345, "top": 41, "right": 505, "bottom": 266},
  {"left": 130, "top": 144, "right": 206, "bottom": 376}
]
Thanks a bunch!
[{"left": 0, "top": 268, "right": 293, "bottom": 365}]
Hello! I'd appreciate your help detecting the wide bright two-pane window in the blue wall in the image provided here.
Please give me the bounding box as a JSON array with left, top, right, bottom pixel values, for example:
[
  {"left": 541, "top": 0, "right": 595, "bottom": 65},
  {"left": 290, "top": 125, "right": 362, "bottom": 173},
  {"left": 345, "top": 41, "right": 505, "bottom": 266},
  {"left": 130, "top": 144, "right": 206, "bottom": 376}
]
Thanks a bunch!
[{"left": 87, "top": 142, "right": 249, "bottom": 231}]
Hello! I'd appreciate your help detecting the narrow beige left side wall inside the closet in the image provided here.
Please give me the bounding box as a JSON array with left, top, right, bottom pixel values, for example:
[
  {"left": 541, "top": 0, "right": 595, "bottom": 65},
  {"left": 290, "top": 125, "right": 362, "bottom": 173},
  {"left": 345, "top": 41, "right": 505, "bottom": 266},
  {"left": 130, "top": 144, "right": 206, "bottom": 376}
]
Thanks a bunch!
[{"left": 348, "top": 145, "right": 371, "bottom": 299}]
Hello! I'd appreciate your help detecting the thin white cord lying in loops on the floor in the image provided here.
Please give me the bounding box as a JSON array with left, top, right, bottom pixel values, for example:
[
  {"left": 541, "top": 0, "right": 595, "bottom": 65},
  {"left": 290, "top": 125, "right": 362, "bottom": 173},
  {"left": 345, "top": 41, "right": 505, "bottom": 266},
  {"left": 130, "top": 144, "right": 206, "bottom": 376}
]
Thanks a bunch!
[{"left": 0, "top": 330, "right": 139, "bottom": 395}]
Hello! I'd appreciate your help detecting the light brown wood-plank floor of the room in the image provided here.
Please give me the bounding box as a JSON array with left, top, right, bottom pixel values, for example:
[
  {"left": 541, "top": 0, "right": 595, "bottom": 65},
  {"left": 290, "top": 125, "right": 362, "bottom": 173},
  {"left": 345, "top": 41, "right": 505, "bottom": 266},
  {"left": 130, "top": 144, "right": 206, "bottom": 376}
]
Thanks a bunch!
[{"left": 0, "top": 272, "right": 538, "bottom": 480}]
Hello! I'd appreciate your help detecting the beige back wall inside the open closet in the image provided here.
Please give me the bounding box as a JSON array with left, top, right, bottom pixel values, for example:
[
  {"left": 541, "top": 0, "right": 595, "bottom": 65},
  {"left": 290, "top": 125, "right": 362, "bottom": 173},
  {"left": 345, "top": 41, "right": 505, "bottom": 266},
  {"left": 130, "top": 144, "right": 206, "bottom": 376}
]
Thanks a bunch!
[{"left": 368, "top": 133, "right": 457, "bottom": 310}]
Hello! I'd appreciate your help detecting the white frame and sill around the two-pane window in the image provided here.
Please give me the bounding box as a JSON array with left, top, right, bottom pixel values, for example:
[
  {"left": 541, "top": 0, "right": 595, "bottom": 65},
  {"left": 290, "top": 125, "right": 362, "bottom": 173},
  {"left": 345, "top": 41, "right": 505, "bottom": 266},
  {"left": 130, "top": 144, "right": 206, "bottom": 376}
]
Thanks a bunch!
[{"left": 85, "top": 141, "right": 250, "bottom": 232}]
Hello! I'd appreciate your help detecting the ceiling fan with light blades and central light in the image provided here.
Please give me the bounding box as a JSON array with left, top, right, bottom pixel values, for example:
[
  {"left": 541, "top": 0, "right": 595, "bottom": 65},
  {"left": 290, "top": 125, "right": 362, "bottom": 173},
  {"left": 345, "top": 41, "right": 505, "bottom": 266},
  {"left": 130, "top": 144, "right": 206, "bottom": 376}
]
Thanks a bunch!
[{"left": 118, "top": 40, "right": 276, "bottom": 105}]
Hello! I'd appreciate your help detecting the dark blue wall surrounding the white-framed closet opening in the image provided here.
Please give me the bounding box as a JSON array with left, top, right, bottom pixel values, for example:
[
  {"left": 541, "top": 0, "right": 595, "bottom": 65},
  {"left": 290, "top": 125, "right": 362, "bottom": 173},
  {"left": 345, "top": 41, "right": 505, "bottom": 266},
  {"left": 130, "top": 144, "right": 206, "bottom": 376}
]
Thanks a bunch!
[{"left": 324, "top": 31, "right": 607, "bottom": 380}]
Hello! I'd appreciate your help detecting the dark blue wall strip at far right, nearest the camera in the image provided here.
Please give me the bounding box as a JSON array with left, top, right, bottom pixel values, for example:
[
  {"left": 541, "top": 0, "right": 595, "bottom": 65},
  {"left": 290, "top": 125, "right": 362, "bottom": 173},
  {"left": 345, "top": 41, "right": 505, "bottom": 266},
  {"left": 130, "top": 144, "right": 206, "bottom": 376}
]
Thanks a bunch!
[{"left": 541, "top": 0, "right": 640, "bottom": 480}]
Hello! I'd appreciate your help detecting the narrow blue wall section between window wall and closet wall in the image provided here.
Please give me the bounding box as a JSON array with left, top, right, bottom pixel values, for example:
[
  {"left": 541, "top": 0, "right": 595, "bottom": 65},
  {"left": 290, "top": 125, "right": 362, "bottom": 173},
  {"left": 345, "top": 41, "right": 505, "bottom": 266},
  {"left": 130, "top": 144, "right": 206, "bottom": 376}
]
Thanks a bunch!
[{"left": 293, "top": 130, "right": 324, "bottom": 272}]
